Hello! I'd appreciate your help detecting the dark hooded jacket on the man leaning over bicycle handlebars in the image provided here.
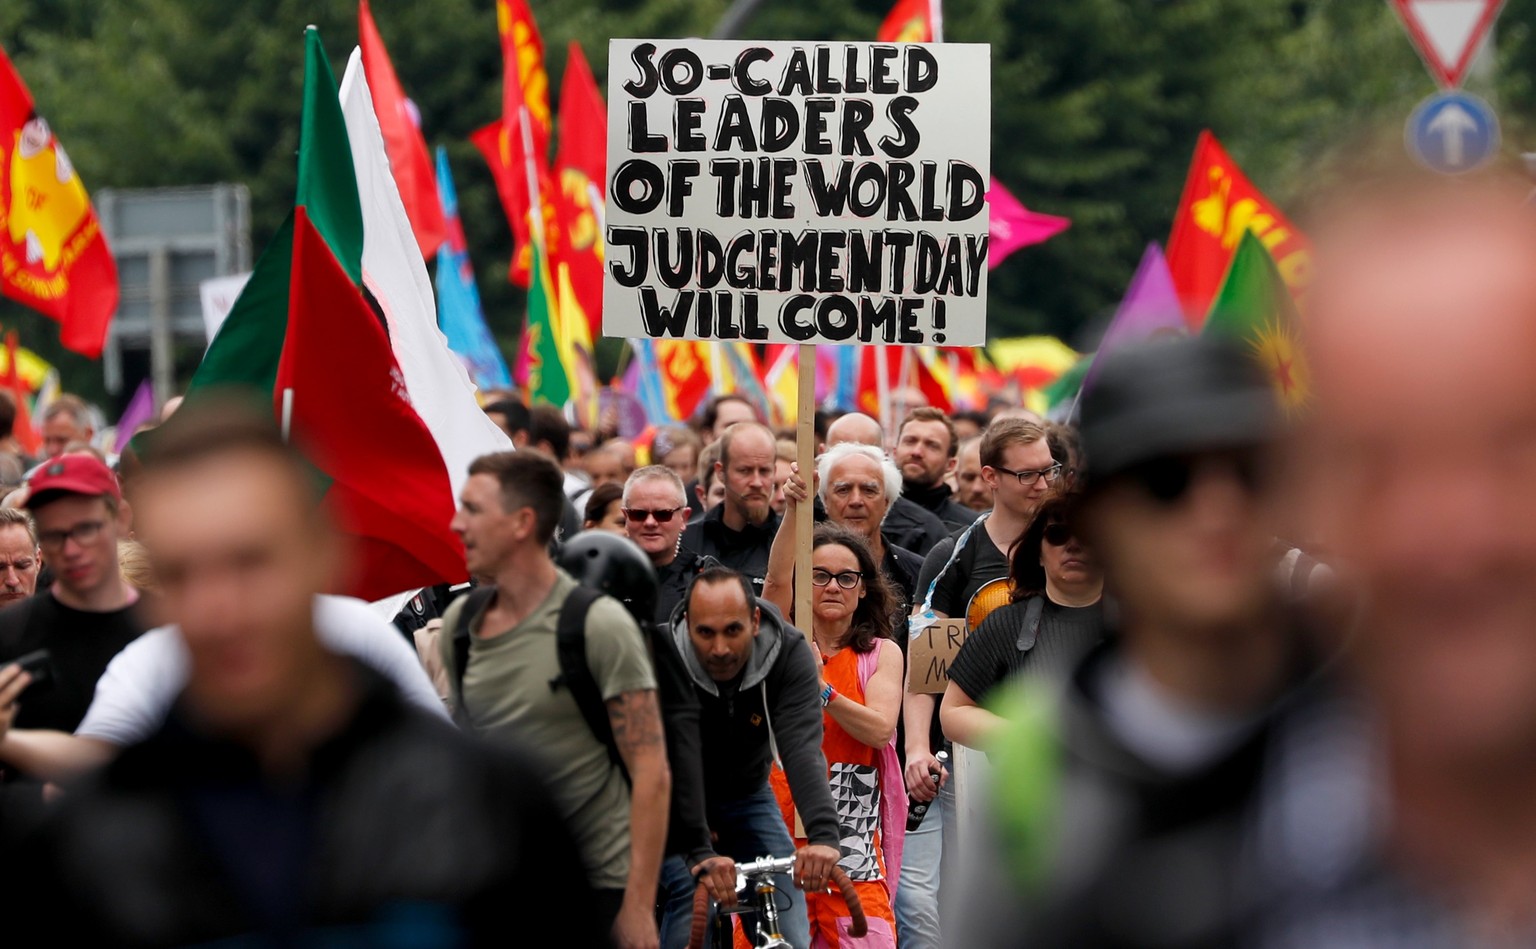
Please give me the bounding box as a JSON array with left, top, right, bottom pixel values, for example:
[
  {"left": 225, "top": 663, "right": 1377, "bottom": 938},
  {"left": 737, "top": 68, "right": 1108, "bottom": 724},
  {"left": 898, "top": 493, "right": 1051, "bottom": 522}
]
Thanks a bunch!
[{"left": 671, "top": 600, "right": 842, "bottom": 857}]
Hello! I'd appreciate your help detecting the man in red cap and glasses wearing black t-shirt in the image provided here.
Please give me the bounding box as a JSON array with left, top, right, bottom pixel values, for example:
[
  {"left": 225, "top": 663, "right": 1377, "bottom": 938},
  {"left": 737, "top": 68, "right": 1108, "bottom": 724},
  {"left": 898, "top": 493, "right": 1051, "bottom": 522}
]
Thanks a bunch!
[{"left": 0, "top": 453, "right": 149, "bottom": 820}]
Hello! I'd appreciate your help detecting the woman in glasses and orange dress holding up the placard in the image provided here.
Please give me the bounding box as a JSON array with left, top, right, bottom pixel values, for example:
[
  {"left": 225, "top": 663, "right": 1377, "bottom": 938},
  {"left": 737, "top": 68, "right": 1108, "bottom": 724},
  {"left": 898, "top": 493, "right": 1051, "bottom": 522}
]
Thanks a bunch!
[{"left": 765, "top": 524, "right": 906, "bottom": 949}]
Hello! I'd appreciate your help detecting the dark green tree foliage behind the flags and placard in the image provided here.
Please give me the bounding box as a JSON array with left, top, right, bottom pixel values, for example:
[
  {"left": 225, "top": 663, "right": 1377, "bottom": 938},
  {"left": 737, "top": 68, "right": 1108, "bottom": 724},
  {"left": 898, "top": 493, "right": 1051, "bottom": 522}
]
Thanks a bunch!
[{"left": 0, "top": 0, "right": 1511, "bottom": 392}]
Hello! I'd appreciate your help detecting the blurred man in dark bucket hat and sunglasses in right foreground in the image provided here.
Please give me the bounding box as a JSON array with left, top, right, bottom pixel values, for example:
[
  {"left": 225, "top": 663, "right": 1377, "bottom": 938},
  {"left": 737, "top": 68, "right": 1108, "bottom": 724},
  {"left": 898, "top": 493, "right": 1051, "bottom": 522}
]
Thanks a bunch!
[{"left": 955, "top": 338, "right": 1312, "bottom": 946}]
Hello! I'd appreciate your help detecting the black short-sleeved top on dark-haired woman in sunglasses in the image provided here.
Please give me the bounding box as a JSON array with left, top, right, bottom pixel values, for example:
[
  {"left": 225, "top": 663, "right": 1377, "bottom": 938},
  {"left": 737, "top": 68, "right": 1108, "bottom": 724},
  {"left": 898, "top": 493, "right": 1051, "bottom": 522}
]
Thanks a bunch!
[{"left": 949, "top": 599, "right": 1104, "bottom": 703}]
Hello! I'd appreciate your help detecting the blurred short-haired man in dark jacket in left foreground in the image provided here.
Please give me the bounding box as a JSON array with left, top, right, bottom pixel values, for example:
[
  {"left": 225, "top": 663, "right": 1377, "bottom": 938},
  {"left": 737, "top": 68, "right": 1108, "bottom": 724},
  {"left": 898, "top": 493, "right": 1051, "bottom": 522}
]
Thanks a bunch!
[{"left": 0, "top": 396, "right": 604, "bottom": 946}]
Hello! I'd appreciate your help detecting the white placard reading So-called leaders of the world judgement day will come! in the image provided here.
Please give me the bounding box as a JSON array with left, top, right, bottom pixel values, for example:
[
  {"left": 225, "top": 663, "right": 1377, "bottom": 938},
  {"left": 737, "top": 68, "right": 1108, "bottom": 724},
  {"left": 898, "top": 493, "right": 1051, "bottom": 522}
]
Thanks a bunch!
[{"left": 602, "top": 40, "right": 992, "bottom": 346}]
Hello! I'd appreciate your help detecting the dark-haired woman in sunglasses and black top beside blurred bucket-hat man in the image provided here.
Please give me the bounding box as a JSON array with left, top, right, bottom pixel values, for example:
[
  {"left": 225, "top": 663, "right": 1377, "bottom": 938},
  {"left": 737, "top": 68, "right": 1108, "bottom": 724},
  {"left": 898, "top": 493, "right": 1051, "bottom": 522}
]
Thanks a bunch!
[{"left": 938, "top": 496, "right": 1104, "bottom": 748}]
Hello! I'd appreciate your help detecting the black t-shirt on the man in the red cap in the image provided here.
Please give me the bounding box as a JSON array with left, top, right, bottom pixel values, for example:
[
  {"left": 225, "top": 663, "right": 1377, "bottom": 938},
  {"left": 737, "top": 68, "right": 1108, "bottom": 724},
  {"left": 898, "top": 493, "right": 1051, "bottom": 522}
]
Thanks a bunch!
[{"left": 0, "top": 593, "right": 146, "bottom": 731}]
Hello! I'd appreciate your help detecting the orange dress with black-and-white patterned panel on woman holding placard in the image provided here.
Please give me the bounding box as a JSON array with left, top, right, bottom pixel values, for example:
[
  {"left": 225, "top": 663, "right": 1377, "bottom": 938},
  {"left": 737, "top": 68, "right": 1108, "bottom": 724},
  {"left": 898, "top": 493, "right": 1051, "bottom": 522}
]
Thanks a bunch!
[{"left": 771, "top": 643, "right": 906, "bottom": 949}]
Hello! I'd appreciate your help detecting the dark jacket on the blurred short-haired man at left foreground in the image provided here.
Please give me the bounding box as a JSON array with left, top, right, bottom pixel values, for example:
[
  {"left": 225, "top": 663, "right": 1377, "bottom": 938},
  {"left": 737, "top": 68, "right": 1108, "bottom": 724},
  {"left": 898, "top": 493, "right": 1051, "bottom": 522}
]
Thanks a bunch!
[{"left": 0, "top": 668, "right": 607, "bottom": 947}]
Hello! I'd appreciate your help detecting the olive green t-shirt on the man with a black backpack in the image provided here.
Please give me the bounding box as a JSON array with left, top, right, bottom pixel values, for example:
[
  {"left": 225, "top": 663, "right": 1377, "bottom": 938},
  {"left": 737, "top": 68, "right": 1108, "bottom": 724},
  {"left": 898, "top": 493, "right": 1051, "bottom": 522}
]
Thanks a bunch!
[{"left": 442, "top": 571, "right": 656, "bottom": 889}]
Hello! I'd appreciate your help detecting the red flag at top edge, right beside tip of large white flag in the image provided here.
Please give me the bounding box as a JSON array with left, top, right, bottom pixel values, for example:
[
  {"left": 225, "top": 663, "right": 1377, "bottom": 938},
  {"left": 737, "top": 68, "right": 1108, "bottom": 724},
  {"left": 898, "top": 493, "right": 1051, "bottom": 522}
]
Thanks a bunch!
[{"left": 358, "top": 0, "right": 449, "bottom": 260}]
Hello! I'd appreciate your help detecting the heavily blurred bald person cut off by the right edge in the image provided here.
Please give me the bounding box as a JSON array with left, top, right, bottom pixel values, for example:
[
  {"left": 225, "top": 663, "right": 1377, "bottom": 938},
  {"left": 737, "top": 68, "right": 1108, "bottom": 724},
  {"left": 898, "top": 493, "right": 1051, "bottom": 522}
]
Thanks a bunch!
[{"left": 1255, "top": 177, "right": 1536, "bottom": 947}]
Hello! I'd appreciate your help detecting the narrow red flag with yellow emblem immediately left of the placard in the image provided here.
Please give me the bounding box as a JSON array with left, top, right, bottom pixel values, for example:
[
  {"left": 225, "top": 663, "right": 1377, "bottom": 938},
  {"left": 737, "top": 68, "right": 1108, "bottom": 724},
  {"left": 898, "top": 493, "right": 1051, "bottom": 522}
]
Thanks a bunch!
[{"left": 554, "top": 41, "right": 608, "bottom": 339}]
